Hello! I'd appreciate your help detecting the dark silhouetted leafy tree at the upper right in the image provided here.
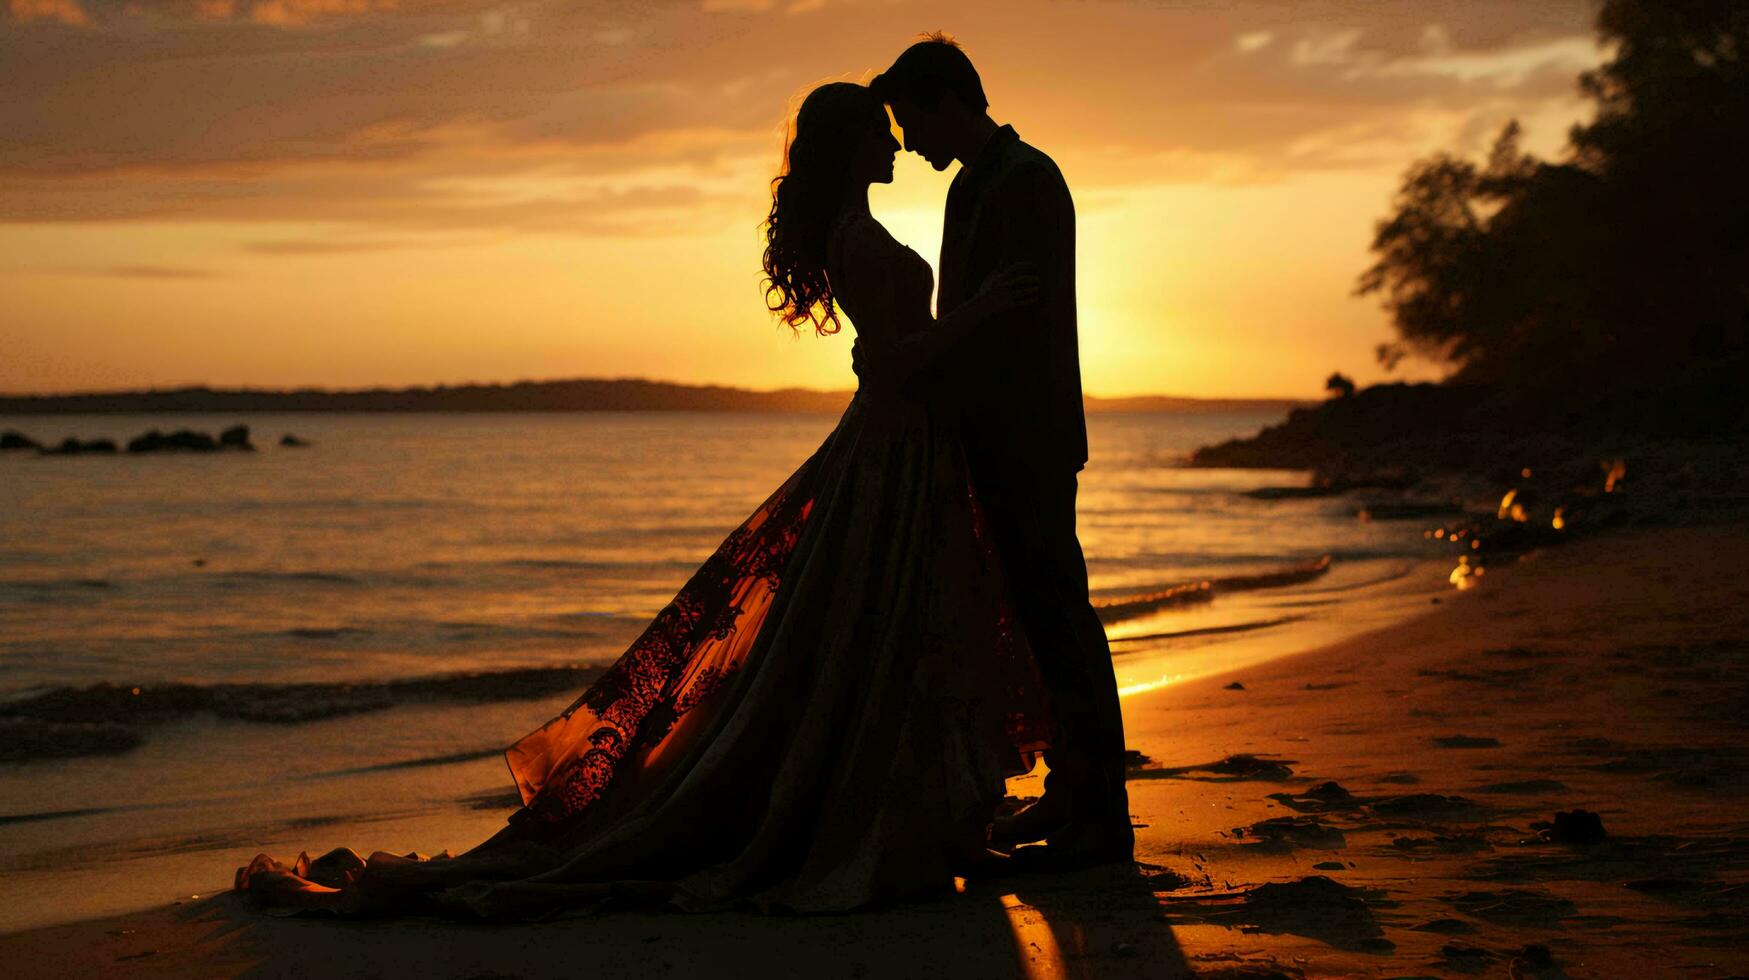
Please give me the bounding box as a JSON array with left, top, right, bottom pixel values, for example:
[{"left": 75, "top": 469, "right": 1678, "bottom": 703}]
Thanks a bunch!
[{"left": 1357, "top": 0, "right": 1749, "bottom": 425}]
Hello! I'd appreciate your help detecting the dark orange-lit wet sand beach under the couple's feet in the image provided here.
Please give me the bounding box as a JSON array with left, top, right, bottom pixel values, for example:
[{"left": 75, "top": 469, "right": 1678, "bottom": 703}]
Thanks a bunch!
[{"left": 0, "top": 527, "right": 1749, "bottom": 978}]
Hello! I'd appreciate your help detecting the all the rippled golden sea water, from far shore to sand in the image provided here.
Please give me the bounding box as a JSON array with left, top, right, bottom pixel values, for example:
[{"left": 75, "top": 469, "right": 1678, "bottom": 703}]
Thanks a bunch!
[{"left": 0, "top": 413, "right": 1441, "bottom": 929}]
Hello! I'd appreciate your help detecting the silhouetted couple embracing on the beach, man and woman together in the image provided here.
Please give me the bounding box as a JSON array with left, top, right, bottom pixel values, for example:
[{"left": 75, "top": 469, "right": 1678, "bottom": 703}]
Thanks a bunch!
[{"left": 238, "top": 35, "right": 1133, "bottom": 919}]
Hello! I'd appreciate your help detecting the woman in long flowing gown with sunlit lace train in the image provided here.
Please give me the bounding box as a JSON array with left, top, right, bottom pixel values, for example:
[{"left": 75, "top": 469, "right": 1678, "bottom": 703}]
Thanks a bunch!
[{"left": 236, "top": 82, "right": 1048, "bottom": 919}]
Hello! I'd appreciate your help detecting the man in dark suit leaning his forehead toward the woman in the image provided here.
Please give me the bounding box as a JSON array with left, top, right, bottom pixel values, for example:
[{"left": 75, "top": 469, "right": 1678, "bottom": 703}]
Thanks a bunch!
[{"left": 869, "top": 35, "right": 1135, "bottom": 868}]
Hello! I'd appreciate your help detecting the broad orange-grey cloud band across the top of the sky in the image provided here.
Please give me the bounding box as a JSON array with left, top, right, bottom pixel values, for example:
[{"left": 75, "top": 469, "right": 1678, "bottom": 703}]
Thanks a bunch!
[{"left": 0, "top": 0, "right": 1595, "bottom": 229}]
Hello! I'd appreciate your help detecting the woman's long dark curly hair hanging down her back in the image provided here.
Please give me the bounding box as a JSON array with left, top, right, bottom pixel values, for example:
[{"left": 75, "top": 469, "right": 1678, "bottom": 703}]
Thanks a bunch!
[{"left": 763, "top": 82, "right": 887, "bottom": 336}]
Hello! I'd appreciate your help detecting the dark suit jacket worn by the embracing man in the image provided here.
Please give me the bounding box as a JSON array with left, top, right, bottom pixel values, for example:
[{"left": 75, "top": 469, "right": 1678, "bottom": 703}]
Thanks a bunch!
[{"left": 936, "top": 126, "right": 1088, "bottom": 476}]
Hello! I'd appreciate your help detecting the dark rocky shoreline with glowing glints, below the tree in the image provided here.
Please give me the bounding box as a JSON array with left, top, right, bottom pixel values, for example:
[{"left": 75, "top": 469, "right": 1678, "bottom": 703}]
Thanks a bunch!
[{"left": 1188, "top": 383, "right": 1749, "bottom": 588}]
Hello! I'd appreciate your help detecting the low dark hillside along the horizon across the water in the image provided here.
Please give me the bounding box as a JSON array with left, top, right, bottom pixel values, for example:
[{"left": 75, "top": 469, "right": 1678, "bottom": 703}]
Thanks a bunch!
[{"left": 0, "top": 378, "right": 1303, "bottom": 415}]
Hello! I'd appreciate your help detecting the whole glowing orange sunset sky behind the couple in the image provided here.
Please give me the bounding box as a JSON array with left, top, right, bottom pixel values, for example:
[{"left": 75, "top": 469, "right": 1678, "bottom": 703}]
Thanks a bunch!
[{"left": 0, "top": 0, "right": 1602, "bottom": 397}]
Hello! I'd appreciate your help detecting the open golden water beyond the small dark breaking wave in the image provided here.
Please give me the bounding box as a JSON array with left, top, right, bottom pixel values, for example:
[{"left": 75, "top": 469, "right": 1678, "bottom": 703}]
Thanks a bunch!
[{"left": 0, "top": 413, "right": 1410, "bottom": 695}]
